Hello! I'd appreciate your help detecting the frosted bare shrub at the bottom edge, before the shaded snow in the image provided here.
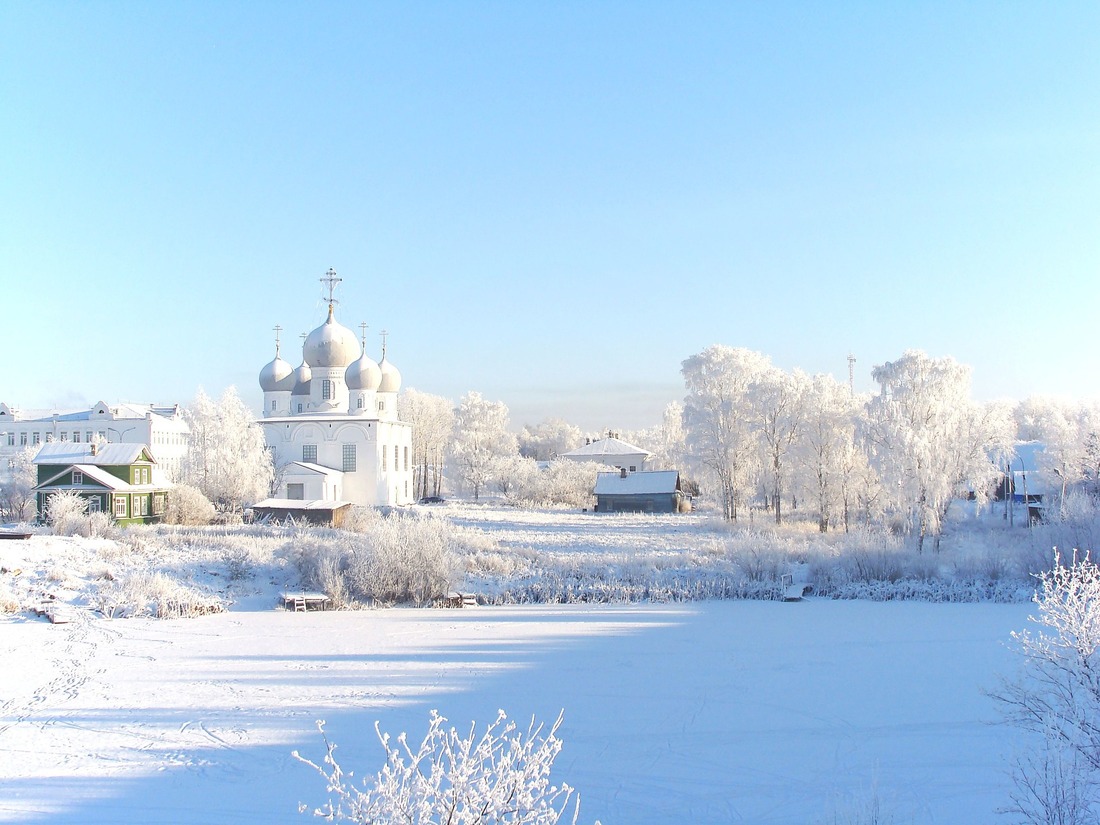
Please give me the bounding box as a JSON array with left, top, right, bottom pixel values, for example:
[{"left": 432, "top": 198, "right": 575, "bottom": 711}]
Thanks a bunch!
[{"left": 294, "top": 711, "right": 598, "bottom": 825}]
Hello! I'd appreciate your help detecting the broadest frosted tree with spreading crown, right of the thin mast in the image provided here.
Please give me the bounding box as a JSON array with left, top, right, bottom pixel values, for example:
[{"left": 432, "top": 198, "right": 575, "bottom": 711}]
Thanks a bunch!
[{"left": 867, "top": 350, "right": 1012, "bottom": 552}]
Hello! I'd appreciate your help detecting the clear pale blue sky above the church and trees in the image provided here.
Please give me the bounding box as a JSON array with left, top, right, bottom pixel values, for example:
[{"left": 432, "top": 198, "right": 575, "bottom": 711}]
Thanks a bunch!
[{"left": 0, "top": 0, "right": 1100, "bottom": 429}]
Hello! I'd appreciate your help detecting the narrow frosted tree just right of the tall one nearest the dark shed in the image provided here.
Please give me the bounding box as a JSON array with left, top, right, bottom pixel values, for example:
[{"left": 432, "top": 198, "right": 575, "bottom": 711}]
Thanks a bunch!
[{"left": 748, "top": 367, "right": 810, "bottom": 525}]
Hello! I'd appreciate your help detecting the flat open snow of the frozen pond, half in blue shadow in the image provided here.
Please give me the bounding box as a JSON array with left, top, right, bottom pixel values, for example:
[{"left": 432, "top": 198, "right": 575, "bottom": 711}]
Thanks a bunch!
[{"left": 0, "top": 508, "right": 1030, "bottom": 825}]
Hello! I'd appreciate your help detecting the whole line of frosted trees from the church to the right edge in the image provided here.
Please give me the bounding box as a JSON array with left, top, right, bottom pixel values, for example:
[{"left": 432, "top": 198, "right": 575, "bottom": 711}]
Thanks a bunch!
[{"left": 400, "top": 345, "right": 1100, "bottom": 549}]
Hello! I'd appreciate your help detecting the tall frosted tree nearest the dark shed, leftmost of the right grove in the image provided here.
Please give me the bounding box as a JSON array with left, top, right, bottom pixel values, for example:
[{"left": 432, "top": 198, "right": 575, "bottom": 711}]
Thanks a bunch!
[{"left": 681, "top": 344, "right": 771, "bottom": 521}]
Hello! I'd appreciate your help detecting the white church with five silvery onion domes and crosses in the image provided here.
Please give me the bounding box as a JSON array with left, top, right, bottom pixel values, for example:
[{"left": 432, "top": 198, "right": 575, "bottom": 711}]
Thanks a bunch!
[{"left": 260, "top": 270, "right": 413, "bottom": 506}]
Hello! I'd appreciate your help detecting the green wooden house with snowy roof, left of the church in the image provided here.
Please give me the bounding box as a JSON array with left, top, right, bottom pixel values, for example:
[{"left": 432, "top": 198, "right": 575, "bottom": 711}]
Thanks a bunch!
[{"left": 34, "top": 441, "right": 168, "bottom": 525}]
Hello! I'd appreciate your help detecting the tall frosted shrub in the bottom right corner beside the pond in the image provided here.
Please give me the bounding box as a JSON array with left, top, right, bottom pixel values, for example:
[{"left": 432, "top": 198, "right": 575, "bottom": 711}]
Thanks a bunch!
[{"left": 992, "top": 557, "right": 1100, "bottom": 823}]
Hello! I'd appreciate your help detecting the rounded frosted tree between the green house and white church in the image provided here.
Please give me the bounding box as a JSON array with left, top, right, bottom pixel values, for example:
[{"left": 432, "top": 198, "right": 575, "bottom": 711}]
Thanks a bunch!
[{"left": 182, "top": 387, "right": 275, "bottom": 513}]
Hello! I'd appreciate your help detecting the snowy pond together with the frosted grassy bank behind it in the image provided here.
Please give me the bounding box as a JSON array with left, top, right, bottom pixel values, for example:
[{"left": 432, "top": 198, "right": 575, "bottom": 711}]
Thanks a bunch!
[{"left": 0, "top": 506, "right": 1064, "bottom": 825}]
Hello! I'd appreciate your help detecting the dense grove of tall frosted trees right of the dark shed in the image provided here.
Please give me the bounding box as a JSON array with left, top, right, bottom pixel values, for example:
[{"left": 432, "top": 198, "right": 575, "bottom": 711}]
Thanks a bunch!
[{"left": 682, "top": 345, "right": 1100, "bottom": 549}]
